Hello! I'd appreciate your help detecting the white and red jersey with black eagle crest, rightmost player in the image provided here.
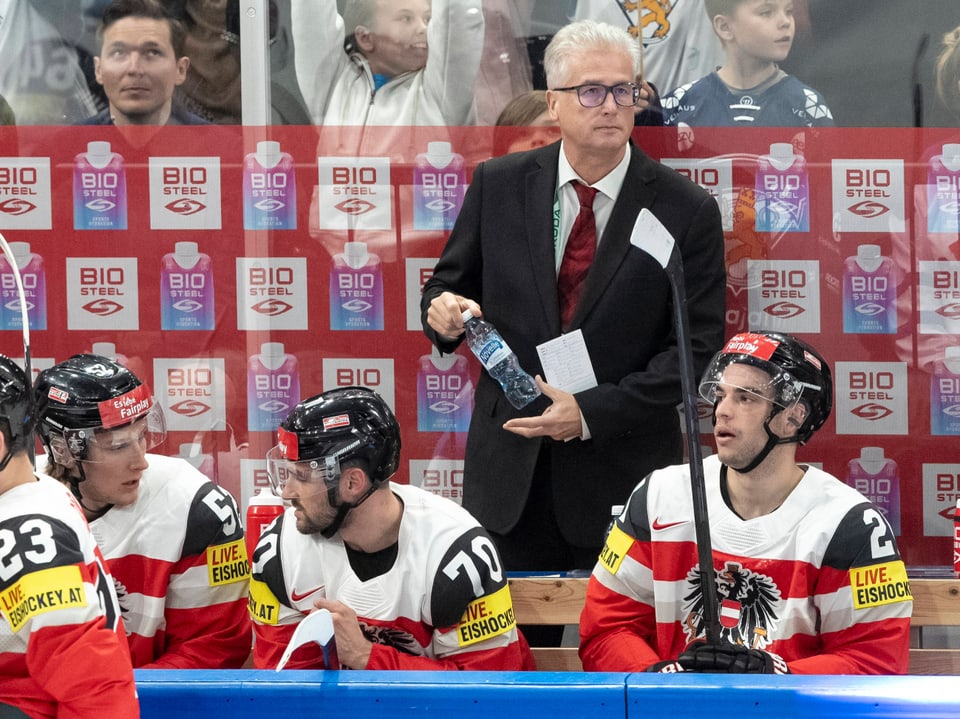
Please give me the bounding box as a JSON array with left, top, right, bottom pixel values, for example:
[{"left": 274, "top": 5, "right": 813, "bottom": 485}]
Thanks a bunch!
[{"left": 580, "top": 456, "right": 913, "bottom": 674}]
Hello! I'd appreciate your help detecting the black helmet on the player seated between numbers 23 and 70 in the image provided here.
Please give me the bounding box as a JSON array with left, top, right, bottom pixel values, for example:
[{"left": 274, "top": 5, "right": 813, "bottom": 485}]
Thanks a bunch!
[{"left": 34, "top": 354, "right": 166, "bottom": 464}]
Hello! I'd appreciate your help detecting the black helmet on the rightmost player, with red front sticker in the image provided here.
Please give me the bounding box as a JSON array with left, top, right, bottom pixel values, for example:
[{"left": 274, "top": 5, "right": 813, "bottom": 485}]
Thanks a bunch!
[{"left": 700, "top": 331, "right": 833, "bottom": 444}]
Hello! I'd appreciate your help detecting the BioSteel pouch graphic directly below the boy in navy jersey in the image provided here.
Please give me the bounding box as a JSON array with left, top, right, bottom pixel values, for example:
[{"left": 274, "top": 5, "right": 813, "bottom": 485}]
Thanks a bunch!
[{"left": 756, "top": 142, "right": 810, "bottom": 232}]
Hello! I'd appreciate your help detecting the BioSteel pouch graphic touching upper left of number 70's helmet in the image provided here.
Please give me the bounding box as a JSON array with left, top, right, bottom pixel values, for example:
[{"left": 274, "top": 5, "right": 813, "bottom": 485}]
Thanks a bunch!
[{"left": 247, "top": 342, "right": 300, "bottom": 432}]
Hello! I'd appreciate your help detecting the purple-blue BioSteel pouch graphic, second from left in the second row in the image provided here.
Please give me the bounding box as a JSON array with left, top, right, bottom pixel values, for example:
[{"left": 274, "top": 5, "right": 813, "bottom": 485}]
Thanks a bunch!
[{"left": 160, "top": 242, "right": 216, "bottom": 330}]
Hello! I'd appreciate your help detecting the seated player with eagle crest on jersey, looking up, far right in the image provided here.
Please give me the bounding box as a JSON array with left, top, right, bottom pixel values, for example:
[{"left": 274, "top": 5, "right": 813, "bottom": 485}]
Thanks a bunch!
[{"left": 580, "top": 332, "right": 913, "bottom": 674}]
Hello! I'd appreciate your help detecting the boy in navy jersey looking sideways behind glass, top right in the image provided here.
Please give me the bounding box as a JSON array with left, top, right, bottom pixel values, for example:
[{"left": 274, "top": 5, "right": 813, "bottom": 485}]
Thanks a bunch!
[{"left": 662, "top": 0, "right": 833, "bottom": 127}]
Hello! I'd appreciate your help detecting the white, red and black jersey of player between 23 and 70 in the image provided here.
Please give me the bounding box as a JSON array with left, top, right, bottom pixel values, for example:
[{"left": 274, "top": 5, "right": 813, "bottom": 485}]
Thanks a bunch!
[{"left": 90, "top": 454, "right": 252, "bottom": 669}]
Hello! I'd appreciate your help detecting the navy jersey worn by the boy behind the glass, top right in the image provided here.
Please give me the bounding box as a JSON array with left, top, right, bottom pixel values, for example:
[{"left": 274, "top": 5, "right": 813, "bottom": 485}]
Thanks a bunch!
[{"left": 661, "top": 72, "right": 833, "bottom": 127}]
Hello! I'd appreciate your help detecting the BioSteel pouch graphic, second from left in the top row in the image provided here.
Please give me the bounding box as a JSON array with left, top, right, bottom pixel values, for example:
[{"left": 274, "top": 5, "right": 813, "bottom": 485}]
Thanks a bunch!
[{"left": 243, "top": 140, "right": 297, "bottom": 230}]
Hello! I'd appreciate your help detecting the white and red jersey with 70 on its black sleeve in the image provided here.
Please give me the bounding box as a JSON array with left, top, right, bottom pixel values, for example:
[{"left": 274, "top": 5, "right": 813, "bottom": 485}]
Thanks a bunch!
[{"left": 250, "top": 483, "right": 533, "bottom": 670}]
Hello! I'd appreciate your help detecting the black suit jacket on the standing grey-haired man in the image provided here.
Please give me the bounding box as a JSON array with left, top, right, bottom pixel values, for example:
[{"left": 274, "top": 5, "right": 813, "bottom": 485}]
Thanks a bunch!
[{"left": 421, "top": 142, "right": 726, "bottom": 547}]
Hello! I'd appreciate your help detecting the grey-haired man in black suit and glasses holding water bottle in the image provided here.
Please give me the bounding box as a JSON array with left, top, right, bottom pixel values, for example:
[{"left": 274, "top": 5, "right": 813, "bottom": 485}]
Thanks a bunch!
[{"left": 421, "top": 21, "right": 725, "bottom": 570}]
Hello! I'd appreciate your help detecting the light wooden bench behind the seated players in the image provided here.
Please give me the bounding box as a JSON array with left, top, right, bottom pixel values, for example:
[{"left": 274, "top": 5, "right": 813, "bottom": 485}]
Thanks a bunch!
[{"left": 510, "top": 577, "right": 960, "bottom": 675}]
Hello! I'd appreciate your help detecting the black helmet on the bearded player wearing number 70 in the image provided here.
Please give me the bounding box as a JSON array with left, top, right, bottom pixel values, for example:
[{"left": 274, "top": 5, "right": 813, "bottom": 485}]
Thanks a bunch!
[{"left": 267, "top": 387, "right": 400, "bottom": 493}]
